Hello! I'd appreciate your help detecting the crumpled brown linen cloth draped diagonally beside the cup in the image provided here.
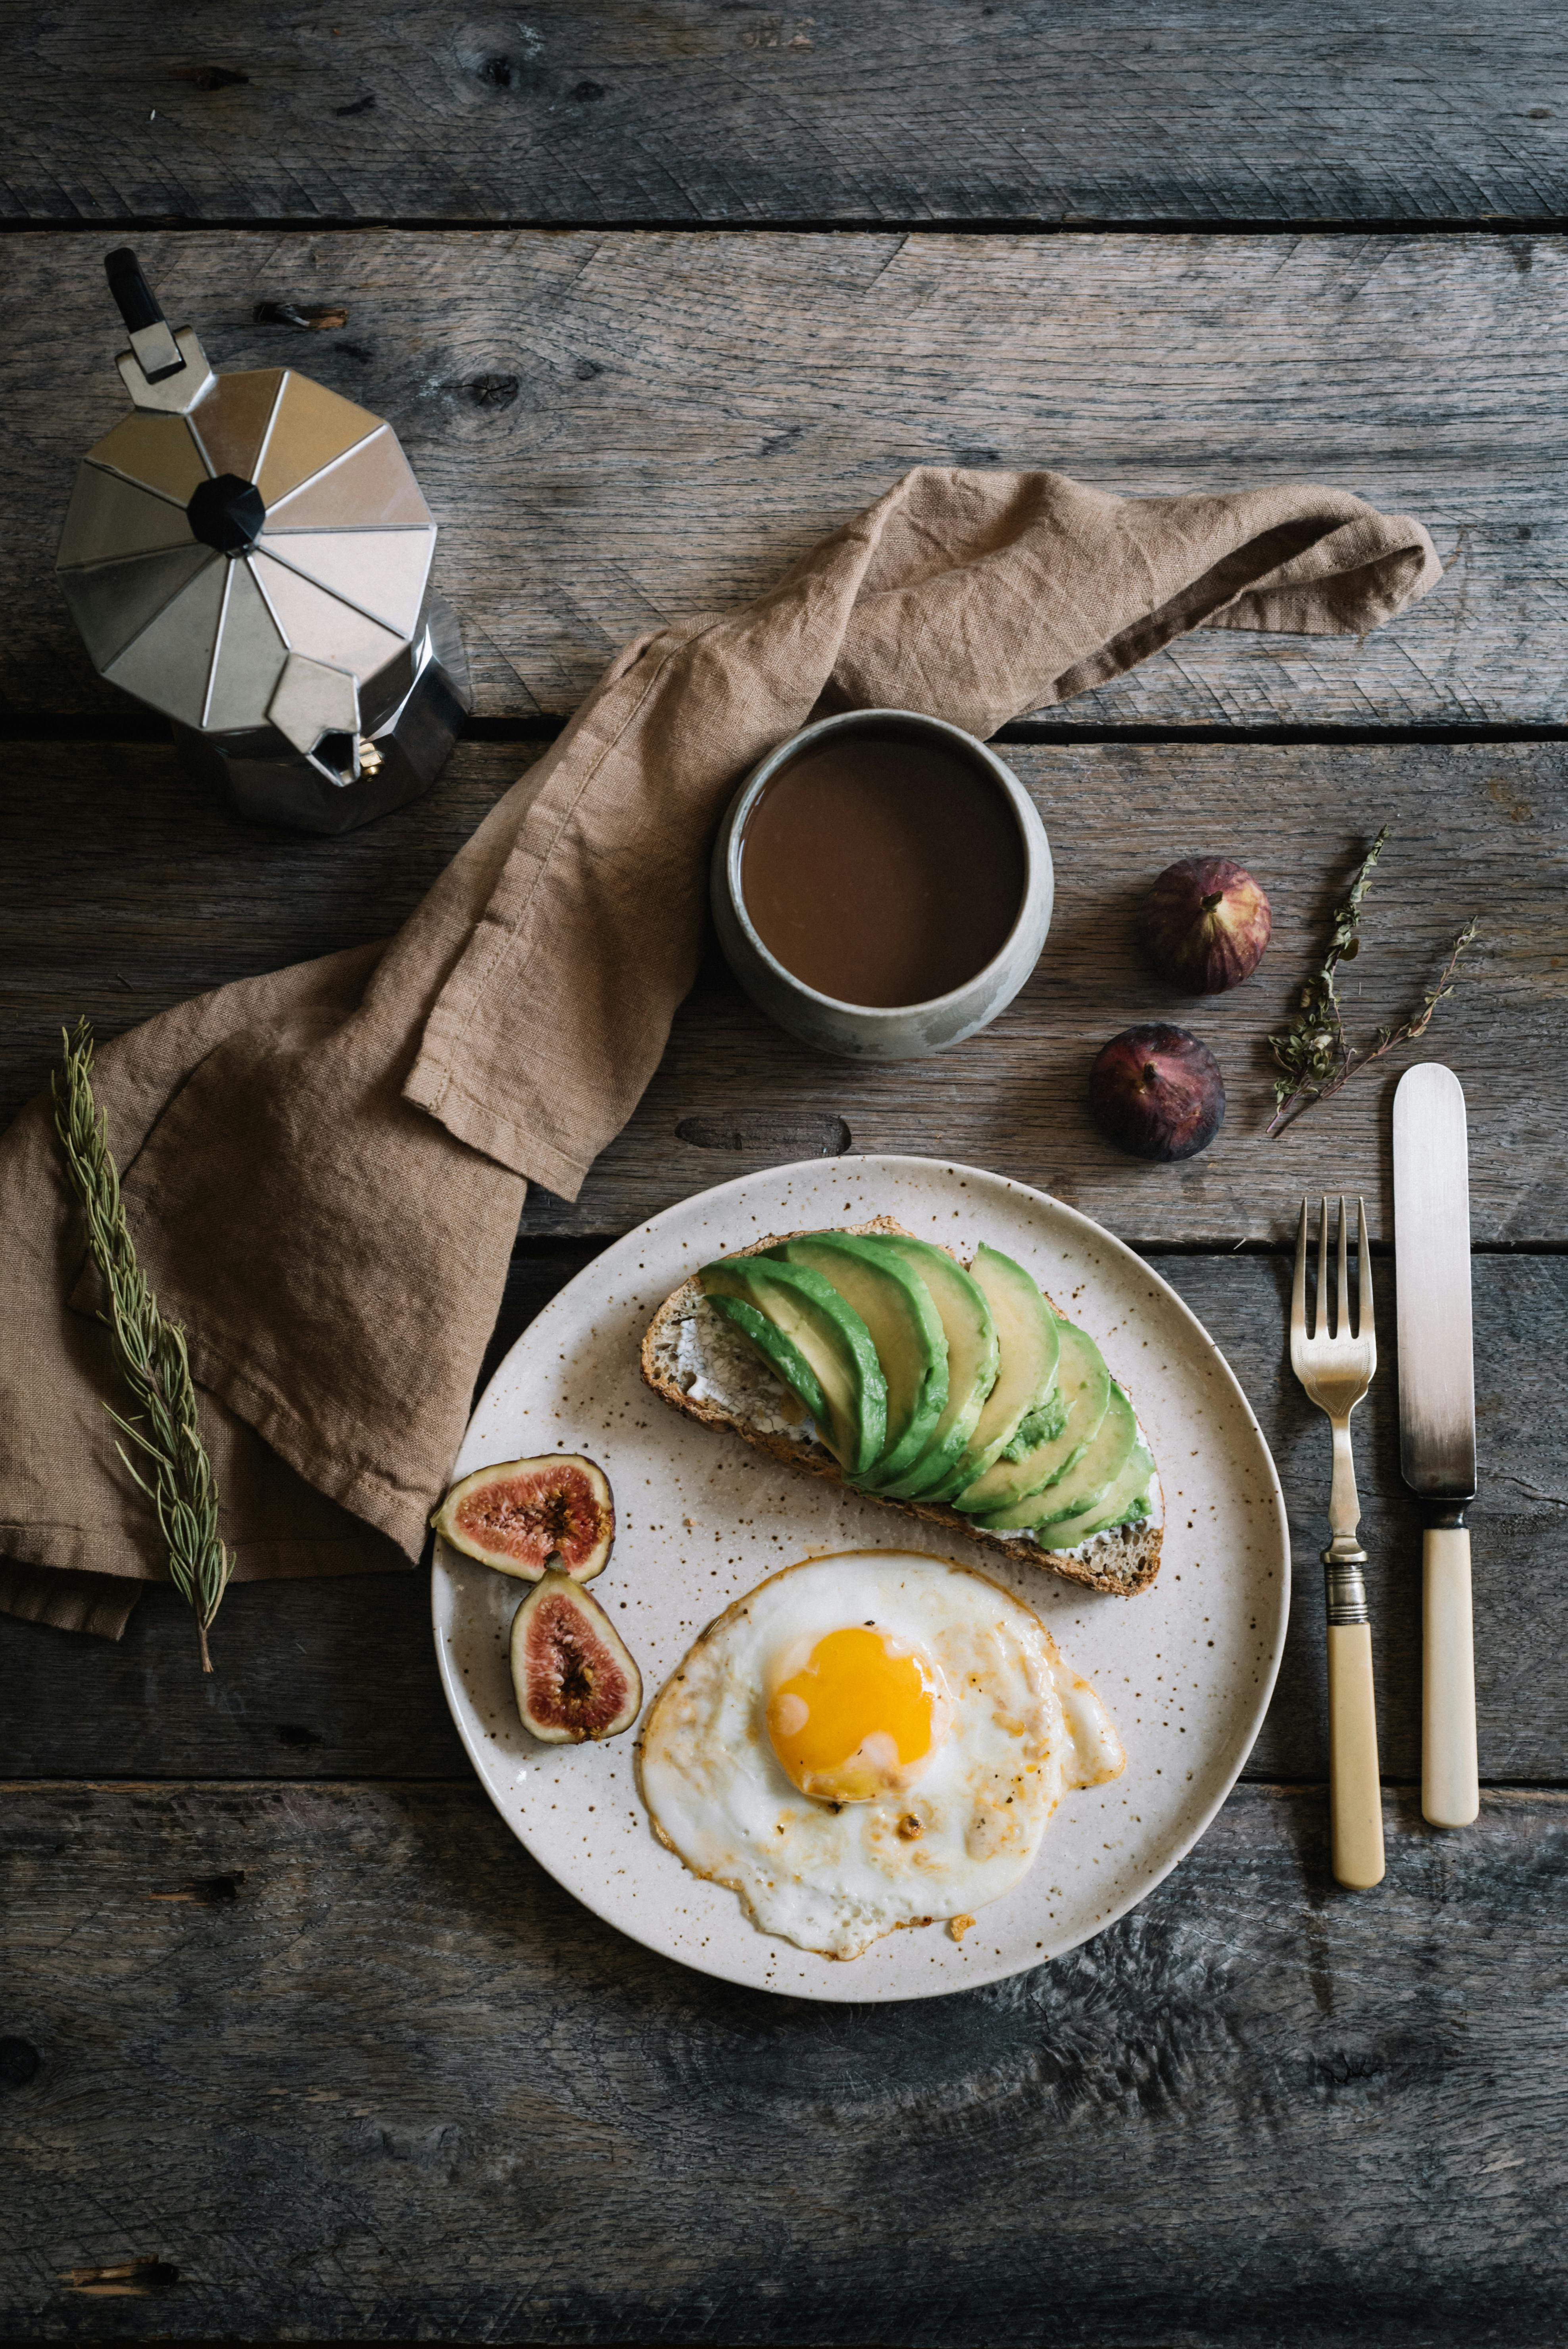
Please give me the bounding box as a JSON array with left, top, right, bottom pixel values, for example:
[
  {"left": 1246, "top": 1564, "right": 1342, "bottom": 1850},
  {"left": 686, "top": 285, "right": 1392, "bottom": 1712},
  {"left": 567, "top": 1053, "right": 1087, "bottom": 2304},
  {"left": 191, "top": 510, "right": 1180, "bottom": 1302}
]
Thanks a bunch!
[{"left": 0, "top": 467, "right": 1441, "bottom": 1637}]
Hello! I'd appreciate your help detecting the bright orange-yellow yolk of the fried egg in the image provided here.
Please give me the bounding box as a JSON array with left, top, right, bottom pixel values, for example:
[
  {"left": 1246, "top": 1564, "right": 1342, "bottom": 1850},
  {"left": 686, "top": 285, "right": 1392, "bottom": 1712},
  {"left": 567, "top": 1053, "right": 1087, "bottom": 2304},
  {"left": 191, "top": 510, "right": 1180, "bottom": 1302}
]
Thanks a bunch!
[{"left": 768, "top": 1623, "right": 946, "bottom": 1802}]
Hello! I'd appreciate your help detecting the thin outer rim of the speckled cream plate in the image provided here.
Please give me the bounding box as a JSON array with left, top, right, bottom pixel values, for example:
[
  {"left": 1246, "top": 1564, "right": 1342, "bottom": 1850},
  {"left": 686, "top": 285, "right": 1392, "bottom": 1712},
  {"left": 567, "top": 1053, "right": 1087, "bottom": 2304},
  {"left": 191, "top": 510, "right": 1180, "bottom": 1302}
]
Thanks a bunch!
[{"left": 430, "top": 1151, "right": 1291, "bottom": 2006}]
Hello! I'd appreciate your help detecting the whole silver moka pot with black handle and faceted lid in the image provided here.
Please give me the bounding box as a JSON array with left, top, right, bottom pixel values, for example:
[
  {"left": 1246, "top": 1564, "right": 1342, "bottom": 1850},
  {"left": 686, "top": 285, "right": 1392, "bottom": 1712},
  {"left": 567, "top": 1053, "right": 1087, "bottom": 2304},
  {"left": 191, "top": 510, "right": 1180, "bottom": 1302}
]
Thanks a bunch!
[{"left": 56, "top": 247, "right": 472, "bottom": 832}]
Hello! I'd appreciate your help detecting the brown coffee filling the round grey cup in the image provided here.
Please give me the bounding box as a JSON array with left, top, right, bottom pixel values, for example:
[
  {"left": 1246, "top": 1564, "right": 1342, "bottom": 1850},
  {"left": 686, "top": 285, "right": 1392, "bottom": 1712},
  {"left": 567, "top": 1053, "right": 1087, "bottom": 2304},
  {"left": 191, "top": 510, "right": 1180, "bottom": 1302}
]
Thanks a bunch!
[{"left": 740, "top": 733, "right": 1023, "bottom": 1008}]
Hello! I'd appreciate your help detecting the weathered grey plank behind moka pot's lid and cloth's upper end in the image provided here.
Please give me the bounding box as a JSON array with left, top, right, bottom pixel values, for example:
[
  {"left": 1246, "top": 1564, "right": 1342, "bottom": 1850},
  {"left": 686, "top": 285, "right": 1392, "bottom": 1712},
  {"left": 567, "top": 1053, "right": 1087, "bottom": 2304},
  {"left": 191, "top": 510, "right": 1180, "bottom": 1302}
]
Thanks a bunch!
[{"left": 12, "top": 230, "right": 1568, "bottom": 726}]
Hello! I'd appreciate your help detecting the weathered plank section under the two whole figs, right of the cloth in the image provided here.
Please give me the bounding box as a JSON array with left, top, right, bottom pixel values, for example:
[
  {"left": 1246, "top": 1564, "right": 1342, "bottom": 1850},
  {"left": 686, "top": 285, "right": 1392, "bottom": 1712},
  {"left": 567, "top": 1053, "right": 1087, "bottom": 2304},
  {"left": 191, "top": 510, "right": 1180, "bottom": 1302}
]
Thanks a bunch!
[{"left": 563, "top": 745, "right": 1568, "bottom": 1245}]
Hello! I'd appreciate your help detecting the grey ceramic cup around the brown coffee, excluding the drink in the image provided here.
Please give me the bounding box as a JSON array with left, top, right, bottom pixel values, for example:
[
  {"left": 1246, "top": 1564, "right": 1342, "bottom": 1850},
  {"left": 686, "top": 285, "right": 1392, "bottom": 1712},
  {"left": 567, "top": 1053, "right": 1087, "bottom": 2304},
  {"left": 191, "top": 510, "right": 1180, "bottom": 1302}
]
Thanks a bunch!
[{"left": 711, "top": 709, "right": 1054, "bottom": 1059}]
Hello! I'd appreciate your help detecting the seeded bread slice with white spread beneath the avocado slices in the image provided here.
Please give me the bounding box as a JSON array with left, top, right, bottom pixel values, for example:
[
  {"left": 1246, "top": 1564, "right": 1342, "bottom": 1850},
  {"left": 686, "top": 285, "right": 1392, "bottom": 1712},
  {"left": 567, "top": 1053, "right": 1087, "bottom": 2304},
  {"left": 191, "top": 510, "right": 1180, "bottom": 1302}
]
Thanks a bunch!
[{"left": 643, "top": 1215, "right": 1164, "bottom": 1597}]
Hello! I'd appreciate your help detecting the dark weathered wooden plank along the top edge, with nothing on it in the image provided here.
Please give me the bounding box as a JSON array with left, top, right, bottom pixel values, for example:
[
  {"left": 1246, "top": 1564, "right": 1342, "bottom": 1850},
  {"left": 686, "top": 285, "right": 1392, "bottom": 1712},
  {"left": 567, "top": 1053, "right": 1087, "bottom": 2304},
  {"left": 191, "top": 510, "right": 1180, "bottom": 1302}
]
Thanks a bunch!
[{"left": 0, "top": 0, "right": 1568, "bottom": 223}]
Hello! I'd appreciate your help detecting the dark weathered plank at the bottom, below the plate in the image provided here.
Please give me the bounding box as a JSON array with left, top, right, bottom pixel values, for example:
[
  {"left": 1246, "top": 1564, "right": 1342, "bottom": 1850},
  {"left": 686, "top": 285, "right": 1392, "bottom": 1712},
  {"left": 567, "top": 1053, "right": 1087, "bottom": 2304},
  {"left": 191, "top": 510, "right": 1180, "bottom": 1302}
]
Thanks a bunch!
[{"left": 0, "top": 1785, "right": 1568, "bottom": 2349}]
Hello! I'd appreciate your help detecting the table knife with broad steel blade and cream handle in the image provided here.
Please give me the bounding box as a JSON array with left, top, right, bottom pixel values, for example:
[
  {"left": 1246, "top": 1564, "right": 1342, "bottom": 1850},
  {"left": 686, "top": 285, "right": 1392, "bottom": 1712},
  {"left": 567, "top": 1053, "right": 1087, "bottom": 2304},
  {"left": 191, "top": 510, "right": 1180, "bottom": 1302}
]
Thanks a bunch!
[{"left": 1394, "top": 1062, "right": 1481, "bottom": 1828}]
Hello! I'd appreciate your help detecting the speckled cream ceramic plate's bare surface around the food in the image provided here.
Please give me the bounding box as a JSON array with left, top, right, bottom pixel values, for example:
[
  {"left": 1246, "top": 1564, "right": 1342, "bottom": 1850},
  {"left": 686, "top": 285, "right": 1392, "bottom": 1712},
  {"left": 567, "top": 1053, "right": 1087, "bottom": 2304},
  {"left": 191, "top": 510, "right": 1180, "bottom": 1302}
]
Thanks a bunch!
[{"left": 434, "top": 1158, "right": 1291, "bottom": 2001}]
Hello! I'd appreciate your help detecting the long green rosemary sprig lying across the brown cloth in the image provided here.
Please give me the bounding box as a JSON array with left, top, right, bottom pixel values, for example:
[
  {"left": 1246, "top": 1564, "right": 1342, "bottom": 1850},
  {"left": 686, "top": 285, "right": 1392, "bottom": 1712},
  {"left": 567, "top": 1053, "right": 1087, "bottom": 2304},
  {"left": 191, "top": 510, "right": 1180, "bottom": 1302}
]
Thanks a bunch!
[{"left": 49, "top": 1019, "right": 233, "bottom": 1672}]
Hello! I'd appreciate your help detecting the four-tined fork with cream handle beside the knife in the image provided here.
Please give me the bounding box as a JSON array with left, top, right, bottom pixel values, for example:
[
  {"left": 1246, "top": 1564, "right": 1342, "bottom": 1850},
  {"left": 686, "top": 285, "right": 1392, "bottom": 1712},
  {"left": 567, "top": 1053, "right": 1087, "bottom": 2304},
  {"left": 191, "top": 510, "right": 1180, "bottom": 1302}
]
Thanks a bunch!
[{"left": 1291, "top": 1196, "right": 1383, "bottom": 1889}]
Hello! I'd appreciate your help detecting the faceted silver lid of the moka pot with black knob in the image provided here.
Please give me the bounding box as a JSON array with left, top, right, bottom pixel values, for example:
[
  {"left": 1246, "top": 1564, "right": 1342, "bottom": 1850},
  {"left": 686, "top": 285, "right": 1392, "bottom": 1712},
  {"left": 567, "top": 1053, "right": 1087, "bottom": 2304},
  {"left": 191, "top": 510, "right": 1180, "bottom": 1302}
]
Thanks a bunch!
[{"left": 56, "top": 256, "right": 436, "bottom": 752}]
